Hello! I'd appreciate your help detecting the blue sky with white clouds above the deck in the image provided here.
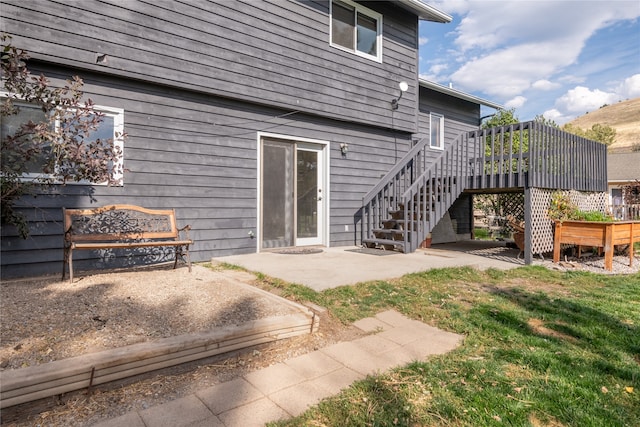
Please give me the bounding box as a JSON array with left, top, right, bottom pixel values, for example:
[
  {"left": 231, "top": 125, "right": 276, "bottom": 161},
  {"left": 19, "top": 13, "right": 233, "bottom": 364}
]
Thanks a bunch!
[{"left": 419, "top": 0, "right": 640, "bottom": 125}]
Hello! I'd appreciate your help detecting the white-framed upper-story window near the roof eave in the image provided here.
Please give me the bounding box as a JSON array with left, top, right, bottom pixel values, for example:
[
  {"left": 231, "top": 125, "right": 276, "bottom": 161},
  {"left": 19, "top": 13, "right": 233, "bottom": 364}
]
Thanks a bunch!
[{"left": 331, "top": 0, "right": 382, "bottom": 62}]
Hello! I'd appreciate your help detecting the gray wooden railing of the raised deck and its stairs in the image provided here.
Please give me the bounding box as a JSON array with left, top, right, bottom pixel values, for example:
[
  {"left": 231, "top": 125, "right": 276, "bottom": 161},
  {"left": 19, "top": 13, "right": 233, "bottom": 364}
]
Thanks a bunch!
[{"left": 362, "top": 122, "right": 607, "bottom": 252}]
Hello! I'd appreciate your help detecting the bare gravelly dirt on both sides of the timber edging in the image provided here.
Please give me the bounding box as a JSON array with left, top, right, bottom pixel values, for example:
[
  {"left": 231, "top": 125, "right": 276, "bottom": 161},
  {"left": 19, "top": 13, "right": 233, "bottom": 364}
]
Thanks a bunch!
[{"left": 0, "top": 266, "right": 361, "bottom": 426}]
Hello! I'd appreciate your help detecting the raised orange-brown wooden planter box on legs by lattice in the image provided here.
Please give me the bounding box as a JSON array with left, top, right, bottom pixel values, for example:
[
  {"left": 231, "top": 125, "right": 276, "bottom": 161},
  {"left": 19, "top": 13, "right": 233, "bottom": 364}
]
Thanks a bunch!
[{"left": 553, "top": 220, "right": 640, "bottom": 271}]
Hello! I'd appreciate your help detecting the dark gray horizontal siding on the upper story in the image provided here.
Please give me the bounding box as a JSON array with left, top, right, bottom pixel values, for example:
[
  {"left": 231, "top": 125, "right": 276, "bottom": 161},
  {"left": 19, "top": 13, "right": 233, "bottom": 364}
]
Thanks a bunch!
[{"left": 1, "top": 0, "right": 418, "bottom": 131}]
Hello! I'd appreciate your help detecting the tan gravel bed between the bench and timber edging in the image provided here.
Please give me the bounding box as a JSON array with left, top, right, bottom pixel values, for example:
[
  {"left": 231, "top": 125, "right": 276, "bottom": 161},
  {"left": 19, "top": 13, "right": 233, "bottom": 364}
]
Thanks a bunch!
[{"left": 0, "top": 266, "right": 294, "bottom": 370}]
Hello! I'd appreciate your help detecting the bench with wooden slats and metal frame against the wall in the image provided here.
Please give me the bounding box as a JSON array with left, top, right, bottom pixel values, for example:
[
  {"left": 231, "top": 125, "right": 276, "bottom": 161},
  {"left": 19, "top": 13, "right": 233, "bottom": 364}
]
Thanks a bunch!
[{"left": 62, "top": 205, "right": 193, "bottom": 281}]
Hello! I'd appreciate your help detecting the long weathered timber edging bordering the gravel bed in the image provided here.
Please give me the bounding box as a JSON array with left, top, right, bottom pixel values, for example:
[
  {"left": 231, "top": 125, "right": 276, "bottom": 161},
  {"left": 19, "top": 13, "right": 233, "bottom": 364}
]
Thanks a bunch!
[{"left": 0, "top": 310, "right": 319, "bottom": 408}]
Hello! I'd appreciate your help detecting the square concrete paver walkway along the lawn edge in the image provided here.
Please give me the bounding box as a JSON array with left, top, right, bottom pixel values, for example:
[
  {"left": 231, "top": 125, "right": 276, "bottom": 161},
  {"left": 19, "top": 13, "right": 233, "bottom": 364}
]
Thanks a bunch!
[{"left": 96, "top": 310, "right": 462, "bottom": 427}]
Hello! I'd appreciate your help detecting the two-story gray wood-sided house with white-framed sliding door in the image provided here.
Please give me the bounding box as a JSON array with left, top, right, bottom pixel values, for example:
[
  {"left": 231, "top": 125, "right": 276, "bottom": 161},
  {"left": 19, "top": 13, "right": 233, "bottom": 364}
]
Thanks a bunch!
[{"left": 0, "top": 0, "right": 603, "bottom": 277}]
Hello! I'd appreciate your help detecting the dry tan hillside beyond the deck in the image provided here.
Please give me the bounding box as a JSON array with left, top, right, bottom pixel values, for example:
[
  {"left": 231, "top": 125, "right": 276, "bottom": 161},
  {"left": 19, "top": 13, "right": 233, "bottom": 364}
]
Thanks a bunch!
[{"left": 569, "top": 98, "right": 640, "bottom": 152}]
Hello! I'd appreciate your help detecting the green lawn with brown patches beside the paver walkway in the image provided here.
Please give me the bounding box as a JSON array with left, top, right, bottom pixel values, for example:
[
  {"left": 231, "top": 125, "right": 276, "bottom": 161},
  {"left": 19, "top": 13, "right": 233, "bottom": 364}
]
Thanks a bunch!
[{"left": 262, "top": 267, "right": 640, "bottom": 426}]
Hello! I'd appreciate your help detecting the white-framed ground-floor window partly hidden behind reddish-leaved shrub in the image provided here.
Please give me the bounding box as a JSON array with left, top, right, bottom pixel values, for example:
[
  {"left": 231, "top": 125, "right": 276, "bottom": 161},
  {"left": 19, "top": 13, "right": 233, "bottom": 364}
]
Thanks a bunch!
[{"left": 0, "top": 93, "right": 124, "bottom": 185}]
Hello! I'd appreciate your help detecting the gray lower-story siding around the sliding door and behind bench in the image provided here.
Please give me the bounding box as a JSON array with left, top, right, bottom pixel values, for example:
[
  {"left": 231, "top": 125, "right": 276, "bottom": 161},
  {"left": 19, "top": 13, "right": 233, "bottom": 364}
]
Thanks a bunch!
[{"left": 1, "top": 63, "right": 410, "bottom": 277}]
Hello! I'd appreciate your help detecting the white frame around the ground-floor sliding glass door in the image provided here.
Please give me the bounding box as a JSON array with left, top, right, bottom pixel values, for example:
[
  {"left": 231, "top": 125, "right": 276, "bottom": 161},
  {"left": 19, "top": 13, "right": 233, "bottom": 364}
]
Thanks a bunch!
[{"left": 256, "top": 132, "right": 331, "bottom": 252}]
